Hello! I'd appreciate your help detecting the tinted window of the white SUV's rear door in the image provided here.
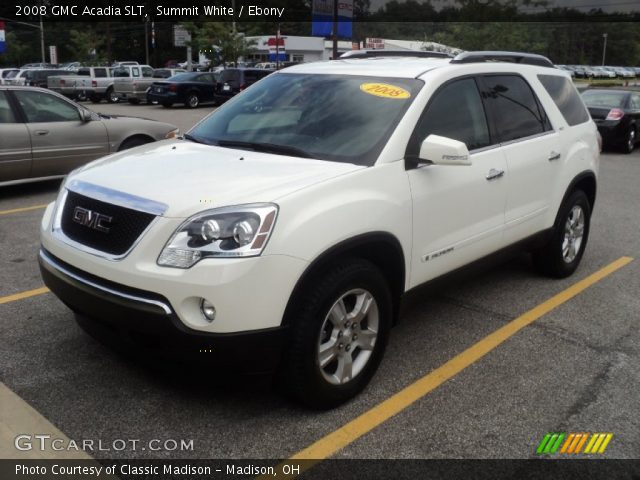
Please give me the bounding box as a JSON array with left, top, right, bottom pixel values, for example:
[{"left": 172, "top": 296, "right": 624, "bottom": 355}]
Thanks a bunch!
[{"left": 482, "top": 75, "right": 551, "bottom": 142}]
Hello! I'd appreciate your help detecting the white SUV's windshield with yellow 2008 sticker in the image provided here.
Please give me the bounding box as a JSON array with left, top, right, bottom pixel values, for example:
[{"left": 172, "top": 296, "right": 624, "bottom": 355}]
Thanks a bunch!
[{"left": 189, "top": 73, "right": 423, "bottom": 165}]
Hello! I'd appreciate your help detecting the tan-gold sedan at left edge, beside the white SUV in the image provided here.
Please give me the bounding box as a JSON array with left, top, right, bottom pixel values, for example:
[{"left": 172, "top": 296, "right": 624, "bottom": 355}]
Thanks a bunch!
[{"left": 0, "top": 86, "right": 179, "bottom": 185}]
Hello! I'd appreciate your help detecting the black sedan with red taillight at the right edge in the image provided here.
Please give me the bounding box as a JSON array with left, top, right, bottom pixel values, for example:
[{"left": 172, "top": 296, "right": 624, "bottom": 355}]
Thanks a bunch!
[{"left": 582, "top": 90, "right": 640, "bottom": 153}]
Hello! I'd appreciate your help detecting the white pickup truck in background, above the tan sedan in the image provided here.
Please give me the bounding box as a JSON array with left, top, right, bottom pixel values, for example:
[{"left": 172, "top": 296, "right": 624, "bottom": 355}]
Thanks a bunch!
[{"left": 47, "top": 67, "right": 118, "bottom": 103}]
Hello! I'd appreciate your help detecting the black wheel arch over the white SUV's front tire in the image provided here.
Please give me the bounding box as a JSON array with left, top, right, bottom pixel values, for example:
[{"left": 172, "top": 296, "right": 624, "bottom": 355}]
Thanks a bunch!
[{"left": 282, "top": 232, "right": 406, "bottom": 325}]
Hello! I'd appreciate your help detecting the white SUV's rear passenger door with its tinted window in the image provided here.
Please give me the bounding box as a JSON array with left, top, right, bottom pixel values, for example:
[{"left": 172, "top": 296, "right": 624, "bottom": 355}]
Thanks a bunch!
[{"left": 481, "top": 74, "right": 567, "bottom": 244}]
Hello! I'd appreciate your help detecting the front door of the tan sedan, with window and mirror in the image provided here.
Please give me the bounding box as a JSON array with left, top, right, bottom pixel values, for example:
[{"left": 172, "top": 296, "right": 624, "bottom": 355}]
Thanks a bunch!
[{"left": 14, "top": 90, "right": 109, "bottom": 177}]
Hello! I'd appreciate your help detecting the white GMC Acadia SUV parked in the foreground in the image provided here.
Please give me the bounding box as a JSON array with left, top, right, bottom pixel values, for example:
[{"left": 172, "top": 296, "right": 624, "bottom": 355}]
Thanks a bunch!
[{"left": 39, "top": 52, "right": 599, "bottom": 408}]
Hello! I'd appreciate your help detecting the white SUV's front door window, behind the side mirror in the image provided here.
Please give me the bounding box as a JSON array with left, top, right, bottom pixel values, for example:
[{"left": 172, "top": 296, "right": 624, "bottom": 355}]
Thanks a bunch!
[{"left": 407, "top": 78, "right": 491, "bottom": 155}]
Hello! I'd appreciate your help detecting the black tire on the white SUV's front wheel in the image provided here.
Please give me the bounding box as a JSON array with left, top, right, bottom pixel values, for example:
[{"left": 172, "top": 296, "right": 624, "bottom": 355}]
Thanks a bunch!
[{"left": 277, "top": 259, "right": 393, "bottom": 409}]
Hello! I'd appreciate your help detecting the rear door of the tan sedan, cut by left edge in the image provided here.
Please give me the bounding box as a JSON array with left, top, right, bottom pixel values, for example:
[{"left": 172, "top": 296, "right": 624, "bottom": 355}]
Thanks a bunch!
[{"left": 0, "top": 90, "right": 31, "bottom": 183}]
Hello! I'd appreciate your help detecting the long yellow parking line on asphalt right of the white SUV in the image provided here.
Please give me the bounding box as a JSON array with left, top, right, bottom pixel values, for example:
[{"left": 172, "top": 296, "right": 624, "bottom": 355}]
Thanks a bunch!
[{"left": 276, "top": 257, "right": 633, "bottom": 478}]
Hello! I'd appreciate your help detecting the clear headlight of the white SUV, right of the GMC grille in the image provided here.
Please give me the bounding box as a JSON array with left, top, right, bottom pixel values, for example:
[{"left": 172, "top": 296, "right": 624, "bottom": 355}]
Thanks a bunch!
[{"left": 158, "top": 203, "right": 278, "bottom": 268}]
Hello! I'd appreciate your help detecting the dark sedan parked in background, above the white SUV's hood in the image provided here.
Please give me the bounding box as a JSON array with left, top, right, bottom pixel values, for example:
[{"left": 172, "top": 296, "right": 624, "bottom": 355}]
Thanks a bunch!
[{"left": 147, "top": 72, "right": 216, "bottom": 108}]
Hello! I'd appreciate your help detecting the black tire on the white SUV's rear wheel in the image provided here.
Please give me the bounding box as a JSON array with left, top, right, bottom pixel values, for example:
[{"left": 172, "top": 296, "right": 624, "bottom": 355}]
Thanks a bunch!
[{"left": 533, "top": 190, "right": 591, "bottom": 278}]
